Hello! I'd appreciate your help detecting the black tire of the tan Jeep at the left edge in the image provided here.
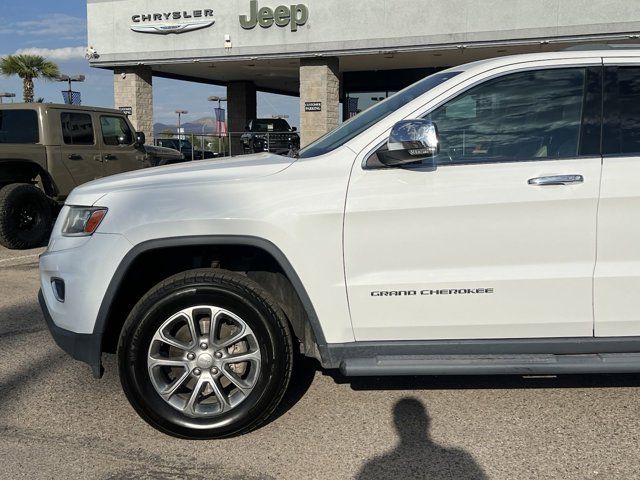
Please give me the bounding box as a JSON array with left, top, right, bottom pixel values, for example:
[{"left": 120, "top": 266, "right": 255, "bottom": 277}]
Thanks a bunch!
[{"left": 0, "top": 183, "right": 52, "bottom": 250}]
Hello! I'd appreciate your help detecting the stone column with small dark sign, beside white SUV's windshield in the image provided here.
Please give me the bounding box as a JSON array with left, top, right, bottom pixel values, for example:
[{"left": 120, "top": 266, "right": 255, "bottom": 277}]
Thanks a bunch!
[{"left": 300, "top": 58, "right": 340, "bottom": 147}]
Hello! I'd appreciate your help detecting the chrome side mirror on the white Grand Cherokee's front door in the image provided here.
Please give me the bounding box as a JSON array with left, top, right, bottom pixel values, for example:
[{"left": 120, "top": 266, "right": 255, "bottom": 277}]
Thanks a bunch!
[{"left": 378, "top": 119, "right": 440, "bottom": 167}]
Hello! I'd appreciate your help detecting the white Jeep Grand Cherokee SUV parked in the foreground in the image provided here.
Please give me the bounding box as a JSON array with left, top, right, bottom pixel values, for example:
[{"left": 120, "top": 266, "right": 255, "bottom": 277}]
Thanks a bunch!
[{"left": 40, "top": 50, "right": 640, "bottom": 438}]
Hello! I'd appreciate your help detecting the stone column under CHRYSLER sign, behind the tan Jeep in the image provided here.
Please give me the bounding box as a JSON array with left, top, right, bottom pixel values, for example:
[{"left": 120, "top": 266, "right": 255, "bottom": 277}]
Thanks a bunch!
[{"left": 113, "top": 66, "right": 153, "bottom": 143}]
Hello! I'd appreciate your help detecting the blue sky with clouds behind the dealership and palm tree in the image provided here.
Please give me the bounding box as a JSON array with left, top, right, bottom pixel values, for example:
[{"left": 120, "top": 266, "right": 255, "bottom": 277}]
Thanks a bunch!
[{"left": 0, "top": 0, "right": 300, "bottom": 126}]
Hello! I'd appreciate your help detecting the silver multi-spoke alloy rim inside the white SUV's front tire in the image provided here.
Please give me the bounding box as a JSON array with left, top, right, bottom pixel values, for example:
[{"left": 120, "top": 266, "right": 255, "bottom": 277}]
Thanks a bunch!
[{"left": 147, "top": 305, "right": 262, "bottom": 418}]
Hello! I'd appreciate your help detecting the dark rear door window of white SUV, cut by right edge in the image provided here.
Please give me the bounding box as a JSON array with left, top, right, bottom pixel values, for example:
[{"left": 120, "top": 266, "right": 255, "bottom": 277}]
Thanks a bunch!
[{"left": 603, "top": 67, "right": 640, "bottom": 155}]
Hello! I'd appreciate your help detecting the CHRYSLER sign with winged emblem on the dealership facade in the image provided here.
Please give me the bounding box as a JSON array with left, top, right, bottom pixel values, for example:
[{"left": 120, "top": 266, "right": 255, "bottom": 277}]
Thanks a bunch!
[{"left": 131, "top": 9, "right": 215, "bottom": 35}]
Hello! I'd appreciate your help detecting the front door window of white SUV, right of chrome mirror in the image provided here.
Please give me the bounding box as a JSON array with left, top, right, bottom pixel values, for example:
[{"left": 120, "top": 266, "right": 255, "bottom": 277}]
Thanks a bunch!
[{"left": 429, "top": 68, "right": 588, "bottom": 165}]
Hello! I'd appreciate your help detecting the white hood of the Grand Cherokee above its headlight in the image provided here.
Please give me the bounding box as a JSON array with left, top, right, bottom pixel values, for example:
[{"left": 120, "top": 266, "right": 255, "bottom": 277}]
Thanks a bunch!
[{"left": 66, "top": 153, "right": 296, "bottom": 205}]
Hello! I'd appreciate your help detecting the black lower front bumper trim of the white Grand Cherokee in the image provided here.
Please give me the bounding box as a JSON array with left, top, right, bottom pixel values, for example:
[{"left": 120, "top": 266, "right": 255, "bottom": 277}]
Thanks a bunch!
[{"left": 38, "top": 290, "right": 104, "bottom": 378}]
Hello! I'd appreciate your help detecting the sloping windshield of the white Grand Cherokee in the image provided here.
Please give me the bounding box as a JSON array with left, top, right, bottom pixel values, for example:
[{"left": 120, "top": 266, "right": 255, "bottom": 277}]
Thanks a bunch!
[{"left": 300, "top": 72, "right": 460, "bottom": 158}]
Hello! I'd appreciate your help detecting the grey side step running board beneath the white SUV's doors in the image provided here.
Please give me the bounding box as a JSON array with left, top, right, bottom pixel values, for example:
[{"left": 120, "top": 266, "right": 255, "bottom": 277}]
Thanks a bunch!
[{"left": 340, "top": 353, "right": 640, "bottom": 377}]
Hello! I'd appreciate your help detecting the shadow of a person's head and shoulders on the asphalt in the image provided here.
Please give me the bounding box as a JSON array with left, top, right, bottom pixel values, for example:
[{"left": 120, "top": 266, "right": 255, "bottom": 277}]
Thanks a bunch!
[{"left": 356, "top": 398, "right": 487, "bottom": 480}]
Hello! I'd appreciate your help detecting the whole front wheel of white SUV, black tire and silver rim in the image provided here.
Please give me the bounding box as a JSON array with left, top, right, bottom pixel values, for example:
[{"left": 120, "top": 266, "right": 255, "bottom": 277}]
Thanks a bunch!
[{"left": 118, "top": 269, "right": 293, "bottom": 439}]
